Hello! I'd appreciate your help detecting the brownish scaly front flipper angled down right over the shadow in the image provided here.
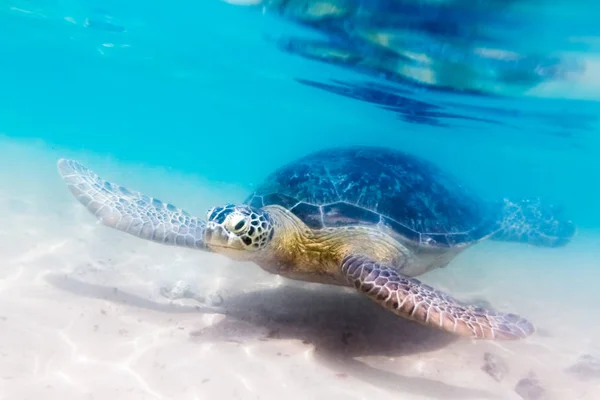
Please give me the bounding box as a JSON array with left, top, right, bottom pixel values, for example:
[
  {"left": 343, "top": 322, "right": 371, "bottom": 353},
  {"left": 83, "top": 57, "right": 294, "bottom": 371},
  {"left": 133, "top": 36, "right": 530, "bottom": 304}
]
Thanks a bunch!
[{"left": 341, "top": 255, "right": 535, "bottom": 340}]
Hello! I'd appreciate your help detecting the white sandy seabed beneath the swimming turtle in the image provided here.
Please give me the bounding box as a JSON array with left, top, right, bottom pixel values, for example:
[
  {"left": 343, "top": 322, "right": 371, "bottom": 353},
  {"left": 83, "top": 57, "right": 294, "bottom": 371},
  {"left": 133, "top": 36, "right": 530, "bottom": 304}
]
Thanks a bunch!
[{"left": 0, "top": 138, "right": 600, "bottom": 400}]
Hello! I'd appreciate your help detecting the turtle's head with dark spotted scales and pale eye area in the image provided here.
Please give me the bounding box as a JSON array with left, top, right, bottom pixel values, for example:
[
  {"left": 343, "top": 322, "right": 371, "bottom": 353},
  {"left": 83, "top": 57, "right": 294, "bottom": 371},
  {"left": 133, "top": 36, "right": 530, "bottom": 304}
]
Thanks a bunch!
[{"left": 205, "top": 204, "right": 274, "bottom": 259}]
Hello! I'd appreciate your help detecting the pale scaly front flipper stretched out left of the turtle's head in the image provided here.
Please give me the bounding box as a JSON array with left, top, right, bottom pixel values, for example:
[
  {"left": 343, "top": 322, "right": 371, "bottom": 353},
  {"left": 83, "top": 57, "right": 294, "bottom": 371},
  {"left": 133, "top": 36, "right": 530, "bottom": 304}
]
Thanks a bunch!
[{"left": 58, "top": 159, "right": 207, "bottom": 250}]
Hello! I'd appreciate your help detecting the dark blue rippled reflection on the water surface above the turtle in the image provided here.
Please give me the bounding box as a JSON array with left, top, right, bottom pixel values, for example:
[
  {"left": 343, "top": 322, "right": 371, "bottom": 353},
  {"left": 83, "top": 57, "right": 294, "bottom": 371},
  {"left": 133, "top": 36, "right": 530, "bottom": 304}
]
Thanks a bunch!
[{"left": 266, "top": 0, "right": 597, "bottom": 130}]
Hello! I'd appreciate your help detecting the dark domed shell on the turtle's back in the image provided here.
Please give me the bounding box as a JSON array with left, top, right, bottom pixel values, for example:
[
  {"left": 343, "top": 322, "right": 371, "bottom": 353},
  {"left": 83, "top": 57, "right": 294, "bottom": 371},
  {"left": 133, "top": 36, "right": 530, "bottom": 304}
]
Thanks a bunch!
[{"left": 246, "top": 146, "right": 498, "bottom": 247}]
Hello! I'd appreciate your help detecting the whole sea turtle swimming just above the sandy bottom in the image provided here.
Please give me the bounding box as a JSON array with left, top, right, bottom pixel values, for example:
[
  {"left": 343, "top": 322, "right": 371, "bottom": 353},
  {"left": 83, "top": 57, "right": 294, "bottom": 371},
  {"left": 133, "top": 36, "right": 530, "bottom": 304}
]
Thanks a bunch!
[{"left": 58, "top": 146, "right": 574, "bottom": 340}]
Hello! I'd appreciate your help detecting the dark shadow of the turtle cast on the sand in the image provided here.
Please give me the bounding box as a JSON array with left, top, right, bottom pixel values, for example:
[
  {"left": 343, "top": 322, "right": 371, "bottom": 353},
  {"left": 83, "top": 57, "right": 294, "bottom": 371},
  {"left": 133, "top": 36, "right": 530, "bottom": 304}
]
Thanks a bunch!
[{"left": 46, "top": 275, "right": 499, "bottom": 399}]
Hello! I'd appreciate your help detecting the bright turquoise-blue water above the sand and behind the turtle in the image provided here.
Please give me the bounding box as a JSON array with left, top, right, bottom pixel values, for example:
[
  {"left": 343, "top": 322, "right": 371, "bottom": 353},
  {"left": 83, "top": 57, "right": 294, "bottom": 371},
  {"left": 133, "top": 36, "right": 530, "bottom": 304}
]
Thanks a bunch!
[{"left": 0, "top": 0, "right": 600, "bottom": 399}]
